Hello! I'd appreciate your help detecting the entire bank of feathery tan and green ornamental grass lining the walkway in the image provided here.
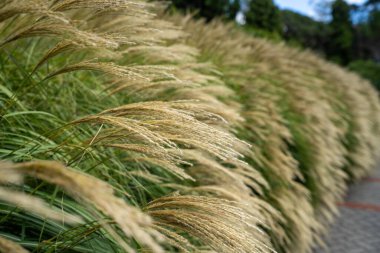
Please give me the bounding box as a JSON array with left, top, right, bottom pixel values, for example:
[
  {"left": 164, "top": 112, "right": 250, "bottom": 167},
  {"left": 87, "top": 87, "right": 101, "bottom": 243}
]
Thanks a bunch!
[{"left": 0, "top": 0, "right": 380, "bottom": 253}]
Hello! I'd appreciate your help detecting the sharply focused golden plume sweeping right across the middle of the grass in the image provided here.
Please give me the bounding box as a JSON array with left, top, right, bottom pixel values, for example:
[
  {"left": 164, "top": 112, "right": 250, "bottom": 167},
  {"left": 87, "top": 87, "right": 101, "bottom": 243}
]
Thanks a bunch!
[{"left": 73, "top": 101, "right": 244, "bottom": 160}]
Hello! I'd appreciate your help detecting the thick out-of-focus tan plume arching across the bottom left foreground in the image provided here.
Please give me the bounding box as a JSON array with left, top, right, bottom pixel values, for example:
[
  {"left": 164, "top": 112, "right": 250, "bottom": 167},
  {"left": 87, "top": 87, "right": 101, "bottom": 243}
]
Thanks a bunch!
[{"left": 3, "top": 161, "right": 163, "bottom": 252}]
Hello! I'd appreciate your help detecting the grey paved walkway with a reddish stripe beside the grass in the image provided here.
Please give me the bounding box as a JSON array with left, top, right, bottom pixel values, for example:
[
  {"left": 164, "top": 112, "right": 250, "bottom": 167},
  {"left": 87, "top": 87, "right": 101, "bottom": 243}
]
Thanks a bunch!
[{"left": 315, "top": 168, "right": 380, "bottom": 253}]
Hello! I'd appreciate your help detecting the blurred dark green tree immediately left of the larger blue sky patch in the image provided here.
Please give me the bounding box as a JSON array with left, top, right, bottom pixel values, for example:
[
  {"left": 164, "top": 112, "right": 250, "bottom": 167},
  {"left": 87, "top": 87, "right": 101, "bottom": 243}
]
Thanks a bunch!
[{"left": 245, "top": 0, "right": 282, "bottom": 32}]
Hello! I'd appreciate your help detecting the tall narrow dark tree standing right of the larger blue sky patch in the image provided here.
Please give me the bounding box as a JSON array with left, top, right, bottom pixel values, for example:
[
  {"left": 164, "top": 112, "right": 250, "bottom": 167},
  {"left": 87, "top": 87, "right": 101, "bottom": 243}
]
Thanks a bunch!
[{"left": 327, "top": 0, "right": 354, "bottom": 65}]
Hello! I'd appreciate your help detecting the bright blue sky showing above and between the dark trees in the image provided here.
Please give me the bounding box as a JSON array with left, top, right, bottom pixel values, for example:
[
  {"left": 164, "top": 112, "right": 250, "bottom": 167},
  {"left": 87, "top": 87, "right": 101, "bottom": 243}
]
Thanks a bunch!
[{"left": 275, "top": 0, "right": 365, "bottom": 18}]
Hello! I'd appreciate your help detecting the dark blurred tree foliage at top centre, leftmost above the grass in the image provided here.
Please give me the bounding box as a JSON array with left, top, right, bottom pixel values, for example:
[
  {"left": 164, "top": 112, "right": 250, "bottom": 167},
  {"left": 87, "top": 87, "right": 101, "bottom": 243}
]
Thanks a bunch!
[{"left": 172, "top": 0, "right": 240, "bottom": 21}]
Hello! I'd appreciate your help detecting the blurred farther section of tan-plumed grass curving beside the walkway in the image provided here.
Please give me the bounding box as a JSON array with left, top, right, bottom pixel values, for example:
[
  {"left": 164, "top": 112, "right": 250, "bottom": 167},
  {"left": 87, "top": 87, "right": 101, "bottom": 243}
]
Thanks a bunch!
[{"left": 168, "top": 16, "right": 379, "bottom": 252}]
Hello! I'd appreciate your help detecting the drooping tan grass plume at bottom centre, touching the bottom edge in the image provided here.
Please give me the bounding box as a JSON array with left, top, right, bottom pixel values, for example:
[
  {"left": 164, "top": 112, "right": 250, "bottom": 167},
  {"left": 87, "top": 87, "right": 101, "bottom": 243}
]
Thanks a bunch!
[{"left": 146, "top": 196, "right": 270, "bottom": 252}]
